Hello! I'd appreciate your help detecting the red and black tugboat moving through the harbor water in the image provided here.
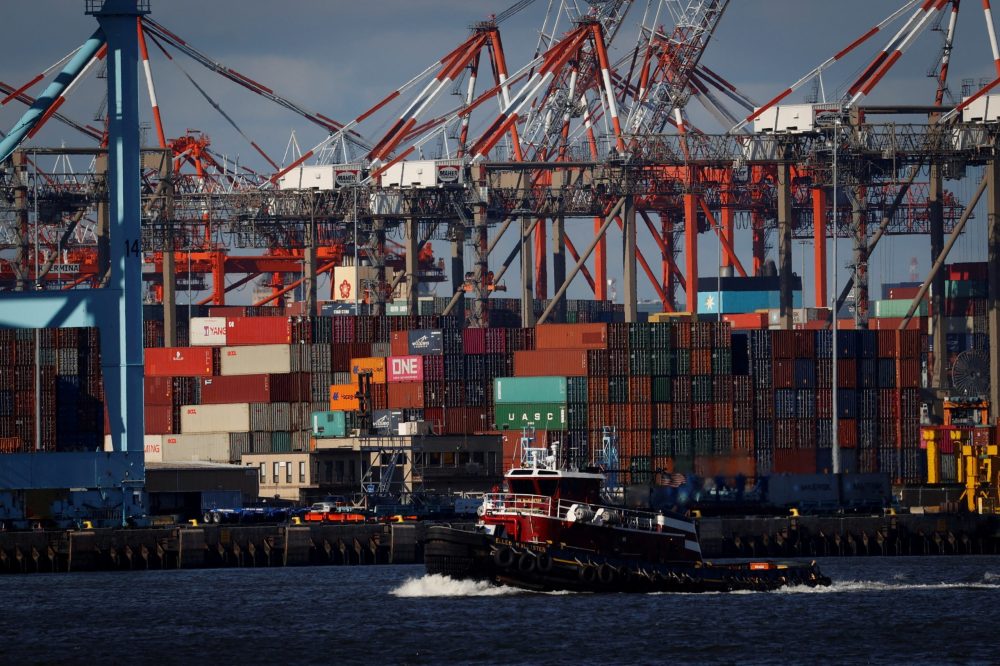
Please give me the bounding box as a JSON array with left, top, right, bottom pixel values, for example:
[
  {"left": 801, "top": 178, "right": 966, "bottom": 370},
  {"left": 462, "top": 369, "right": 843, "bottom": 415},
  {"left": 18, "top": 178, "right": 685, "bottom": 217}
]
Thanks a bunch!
[{"left": 424, "top": 444, "right": 830, "bottom": 592}]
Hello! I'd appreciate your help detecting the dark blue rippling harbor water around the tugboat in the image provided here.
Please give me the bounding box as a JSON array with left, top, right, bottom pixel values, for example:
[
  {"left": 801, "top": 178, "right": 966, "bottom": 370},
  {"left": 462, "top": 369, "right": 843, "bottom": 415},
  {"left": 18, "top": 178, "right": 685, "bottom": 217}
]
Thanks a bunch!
[{"left": 0, "top": 557, "right": 1000, "bottom": 665}]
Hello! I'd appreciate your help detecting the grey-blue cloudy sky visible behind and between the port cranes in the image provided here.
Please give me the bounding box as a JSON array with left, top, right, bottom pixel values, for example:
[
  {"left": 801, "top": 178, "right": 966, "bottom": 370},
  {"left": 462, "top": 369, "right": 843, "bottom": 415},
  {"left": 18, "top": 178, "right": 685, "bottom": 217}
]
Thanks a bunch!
[{"left": 0, "top": 0, "right": 993, "bottom": 304}]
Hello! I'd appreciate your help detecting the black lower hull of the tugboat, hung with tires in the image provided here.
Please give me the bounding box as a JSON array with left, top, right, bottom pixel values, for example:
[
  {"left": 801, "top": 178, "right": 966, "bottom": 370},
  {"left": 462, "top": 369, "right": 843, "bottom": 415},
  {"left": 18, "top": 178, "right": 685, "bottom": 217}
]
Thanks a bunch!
[{"left": 424, "top": 526, "right": 830, "bottom": 592}]
